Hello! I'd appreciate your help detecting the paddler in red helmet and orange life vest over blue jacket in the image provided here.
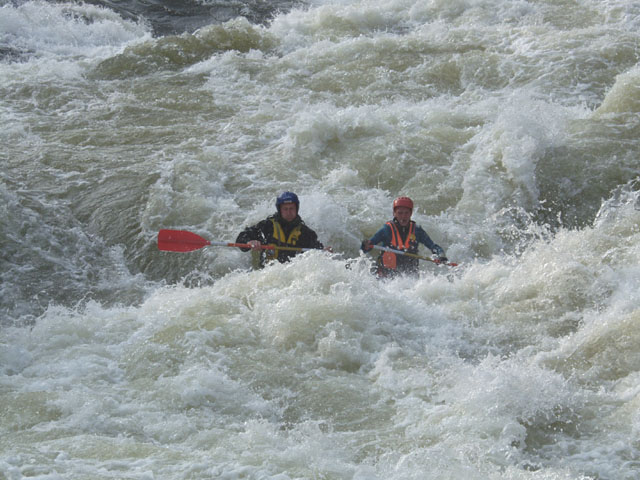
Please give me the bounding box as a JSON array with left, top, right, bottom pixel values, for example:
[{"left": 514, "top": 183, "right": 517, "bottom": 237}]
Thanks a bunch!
[{"left": 362, "top": 197, "right": 449, "bottom": 277}]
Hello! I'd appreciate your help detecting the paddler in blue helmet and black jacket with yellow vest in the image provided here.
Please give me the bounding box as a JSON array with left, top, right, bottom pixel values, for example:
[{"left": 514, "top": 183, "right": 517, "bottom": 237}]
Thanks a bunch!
[{"left": 236, "top": 192, "right": 324, "bottom": 268}]
